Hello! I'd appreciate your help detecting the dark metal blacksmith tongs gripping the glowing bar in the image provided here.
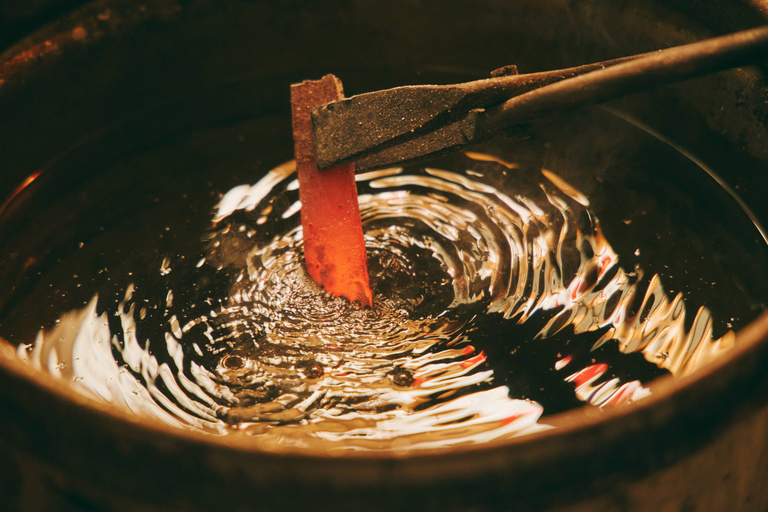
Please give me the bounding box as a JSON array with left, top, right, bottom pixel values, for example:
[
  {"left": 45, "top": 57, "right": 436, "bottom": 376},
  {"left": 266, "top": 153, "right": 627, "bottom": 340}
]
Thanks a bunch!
[{"left": 312, "top": 26, "right": 768, "bottom": 170}]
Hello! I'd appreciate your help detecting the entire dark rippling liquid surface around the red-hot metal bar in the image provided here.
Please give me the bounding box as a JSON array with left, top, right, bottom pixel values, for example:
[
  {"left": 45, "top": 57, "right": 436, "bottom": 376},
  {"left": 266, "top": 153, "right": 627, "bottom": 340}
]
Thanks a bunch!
[{"left": 0, "top": 108, "right": 766, "bottom": 450}]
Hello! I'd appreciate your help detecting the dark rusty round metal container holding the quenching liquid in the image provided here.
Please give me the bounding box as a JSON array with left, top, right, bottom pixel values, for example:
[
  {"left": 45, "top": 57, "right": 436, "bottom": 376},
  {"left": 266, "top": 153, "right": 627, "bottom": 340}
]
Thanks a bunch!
[{"left": 0, "top": 0, "right": 768, "bottom": 511}]
